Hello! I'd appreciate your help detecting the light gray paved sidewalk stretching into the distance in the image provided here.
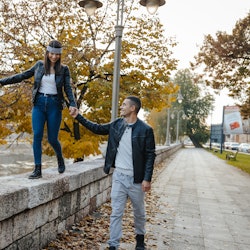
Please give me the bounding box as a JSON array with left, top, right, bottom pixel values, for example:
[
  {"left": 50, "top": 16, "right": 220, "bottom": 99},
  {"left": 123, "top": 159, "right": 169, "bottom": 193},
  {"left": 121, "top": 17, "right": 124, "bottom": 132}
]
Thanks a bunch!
[{"left": 102, "top": 148, "right": 250, "bottom": 250}]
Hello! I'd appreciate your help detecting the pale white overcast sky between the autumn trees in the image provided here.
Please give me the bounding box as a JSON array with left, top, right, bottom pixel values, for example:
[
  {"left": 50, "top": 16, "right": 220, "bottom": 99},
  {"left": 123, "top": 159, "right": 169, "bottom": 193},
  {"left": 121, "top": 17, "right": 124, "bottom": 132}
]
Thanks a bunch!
[{"left": 158, "top": 0, "right": 250, "bottom": 124}]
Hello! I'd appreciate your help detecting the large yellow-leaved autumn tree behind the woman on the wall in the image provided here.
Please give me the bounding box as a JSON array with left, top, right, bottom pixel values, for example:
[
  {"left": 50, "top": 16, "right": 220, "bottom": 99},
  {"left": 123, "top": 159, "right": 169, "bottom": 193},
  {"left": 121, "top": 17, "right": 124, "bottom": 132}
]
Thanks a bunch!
[{"left": 0, "top": 0, "right": 177, "bottom": 158}]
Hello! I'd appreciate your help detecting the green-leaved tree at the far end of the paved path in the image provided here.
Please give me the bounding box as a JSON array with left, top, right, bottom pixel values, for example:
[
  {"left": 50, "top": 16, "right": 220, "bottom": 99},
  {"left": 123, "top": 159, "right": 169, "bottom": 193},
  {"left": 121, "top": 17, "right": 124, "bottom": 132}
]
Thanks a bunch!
[{"left": 148, "top": 69, "right": 213, "bottom": 147}]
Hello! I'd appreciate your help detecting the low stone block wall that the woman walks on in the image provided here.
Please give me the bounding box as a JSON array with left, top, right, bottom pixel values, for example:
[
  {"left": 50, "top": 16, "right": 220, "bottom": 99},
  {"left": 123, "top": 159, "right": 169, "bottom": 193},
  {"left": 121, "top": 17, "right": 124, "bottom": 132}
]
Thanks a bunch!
[{"left": 0, "top": 145, "right": 181, "bottom": 250}]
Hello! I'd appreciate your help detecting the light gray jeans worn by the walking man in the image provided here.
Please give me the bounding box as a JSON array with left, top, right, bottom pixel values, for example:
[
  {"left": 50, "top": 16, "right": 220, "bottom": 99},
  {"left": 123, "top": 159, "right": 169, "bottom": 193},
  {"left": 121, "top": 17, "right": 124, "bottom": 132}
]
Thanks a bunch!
[{"left": 108, "top": 170, "right": 146, "bottom": 248}]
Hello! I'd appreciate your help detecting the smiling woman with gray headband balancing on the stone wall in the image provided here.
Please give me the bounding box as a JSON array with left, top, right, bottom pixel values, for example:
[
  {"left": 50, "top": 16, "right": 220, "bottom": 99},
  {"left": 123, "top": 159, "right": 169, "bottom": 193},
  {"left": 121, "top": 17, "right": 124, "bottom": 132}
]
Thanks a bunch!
[{"left": 0, "top": 40, "right": 77, "bottom": 179}]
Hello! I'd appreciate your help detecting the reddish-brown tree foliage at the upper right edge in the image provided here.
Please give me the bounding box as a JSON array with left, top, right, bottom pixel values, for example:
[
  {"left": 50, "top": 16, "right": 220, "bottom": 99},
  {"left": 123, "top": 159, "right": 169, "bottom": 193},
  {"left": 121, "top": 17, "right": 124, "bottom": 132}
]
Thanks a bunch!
[{"left": 192, "top": 13, "right": 250, "bottom": 117}]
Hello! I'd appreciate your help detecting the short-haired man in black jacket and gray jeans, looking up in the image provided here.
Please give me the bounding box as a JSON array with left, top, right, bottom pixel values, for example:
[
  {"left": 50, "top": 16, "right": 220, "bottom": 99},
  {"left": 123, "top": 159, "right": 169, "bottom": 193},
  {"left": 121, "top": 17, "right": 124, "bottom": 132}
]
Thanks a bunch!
[{"left": 72, "top": 96, "right": 155, "bottom": 250}]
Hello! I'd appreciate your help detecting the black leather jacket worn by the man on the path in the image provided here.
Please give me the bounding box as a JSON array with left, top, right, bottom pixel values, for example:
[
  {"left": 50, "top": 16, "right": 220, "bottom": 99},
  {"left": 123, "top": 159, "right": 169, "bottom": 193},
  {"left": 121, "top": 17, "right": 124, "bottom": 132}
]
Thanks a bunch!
[{"left": 76, "top": 115, "right": 155, "bottom": 183}]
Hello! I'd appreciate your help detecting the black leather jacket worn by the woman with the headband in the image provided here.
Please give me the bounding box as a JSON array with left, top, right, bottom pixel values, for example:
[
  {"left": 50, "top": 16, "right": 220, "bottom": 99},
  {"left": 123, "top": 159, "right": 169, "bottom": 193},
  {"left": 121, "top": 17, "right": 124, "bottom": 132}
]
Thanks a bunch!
[{"left": 0, "top": 61, "right": 76, "bottom": 107}]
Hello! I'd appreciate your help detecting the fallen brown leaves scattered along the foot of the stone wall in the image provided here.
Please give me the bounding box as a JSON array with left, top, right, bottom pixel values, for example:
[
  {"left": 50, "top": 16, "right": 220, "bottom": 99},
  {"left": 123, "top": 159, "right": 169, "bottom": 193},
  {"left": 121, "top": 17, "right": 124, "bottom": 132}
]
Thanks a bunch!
[{"left": 43, "top": 161, "right": 172, "bottom": 250}]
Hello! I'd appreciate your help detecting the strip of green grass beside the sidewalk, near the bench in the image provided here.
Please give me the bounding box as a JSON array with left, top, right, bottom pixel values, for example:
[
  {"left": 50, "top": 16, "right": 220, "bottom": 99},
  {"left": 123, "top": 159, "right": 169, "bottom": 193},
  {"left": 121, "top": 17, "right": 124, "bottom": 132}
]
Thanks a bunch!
[{"left": 208, "top": 149, "right": 250, "bottom": 174}]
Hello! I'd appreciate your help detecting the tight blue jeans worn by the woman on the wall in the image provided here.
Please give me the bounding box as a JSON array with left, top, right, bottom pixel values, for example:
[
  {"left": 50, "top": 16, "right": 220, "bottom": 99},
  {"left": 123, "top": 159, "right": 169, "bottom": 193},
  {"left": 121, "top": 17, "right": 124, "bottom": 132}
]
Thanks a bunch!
[{"left": 32, "top": 95, "right": 62, "bottom": 165}]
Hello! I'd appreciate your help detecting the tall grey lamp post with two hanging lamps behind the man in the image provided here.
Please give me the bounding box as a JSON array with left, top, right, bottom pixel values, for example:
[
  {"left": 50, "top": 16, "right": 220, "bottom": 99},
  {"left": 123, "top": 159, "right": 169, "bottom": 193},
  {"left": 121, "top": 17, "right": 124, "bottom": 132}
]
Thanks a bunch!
[{"left": 79, "top": 0, "right": 165, "bottom": 121}]
